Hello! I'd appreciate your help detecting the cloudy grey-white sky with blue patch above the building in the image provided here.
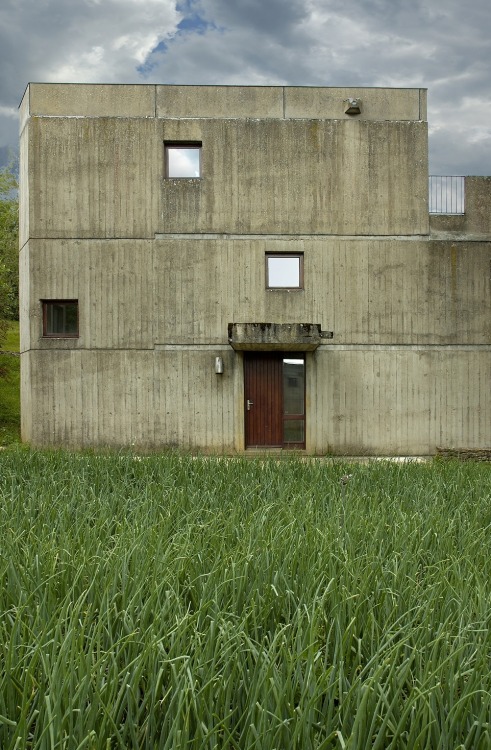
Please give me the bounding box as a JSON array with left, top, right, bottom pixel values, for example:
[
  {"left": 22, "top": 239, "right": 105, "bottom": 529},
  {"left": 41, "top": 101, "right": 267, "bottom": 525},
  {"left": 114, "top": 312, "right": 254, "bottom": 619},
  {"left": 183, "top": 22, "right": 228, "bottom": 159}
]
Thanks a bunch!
[{"left": 0, "top": 0, "right": 491, "bottom": 175}]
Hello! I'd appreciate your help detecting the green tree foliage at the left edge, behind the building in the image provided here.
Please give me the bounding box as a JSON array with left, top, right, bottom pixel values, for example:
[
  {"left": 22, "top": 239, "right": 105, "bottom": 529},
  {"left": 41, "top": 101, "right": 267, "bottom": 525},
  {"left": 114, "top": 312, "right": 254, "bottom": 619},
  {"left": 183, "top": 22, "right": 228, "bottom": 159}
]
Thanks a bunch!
[{"left": 0, "top": 167, "right": 19, "bottom": 341}]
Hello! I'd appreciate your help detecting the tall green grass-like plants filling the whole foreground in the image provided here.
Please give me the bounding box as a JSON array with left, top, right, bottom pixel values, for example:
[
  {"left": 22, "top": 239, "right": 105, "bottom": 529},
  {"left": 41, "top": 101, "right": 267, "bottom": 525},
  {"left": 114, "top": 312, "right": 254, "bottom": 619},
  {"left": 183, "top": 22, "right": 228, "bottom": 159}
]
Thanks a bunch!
[{"left": 0, "top": 448, "right": 491, "bottom": 750}]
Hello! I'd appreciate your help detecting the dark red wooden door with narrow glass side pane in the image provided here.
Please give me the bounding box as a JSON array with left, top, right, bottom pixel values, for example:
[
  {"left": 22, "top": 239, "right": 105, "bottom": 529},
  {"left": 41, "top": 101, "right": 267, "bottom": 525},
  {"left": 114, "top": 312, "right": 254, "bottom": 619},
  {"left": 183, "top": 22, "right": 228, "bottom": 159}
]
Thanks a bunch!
[{"left": 244, "top": 352, "right": 305, "bottom": 448}]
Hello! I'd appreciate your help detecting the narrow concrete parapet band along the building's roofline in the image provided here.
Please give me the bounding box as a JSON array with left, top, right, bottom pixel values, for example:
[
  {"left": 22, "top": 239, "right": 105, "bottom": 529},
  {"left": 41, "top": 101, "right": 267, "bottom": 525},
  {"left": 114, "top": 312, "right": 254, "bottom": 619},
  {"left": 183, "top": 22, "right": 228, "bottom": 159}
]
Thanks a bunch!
[{"left": 22, "top": 83, "right": 426, "bottom": 122}]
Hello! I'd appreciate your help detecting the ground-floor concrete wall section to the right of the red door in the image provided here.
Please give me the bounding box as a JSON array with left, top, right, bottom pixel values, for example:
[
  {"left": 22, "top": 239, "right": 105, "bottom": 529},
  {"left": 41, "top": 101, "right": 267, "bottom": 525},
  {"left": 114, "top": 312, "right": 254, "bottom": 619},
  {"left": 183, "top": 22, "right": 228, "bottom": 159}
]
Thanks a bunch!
[{"left": 306, "top": 346, "right": 491, "bottom": 455}]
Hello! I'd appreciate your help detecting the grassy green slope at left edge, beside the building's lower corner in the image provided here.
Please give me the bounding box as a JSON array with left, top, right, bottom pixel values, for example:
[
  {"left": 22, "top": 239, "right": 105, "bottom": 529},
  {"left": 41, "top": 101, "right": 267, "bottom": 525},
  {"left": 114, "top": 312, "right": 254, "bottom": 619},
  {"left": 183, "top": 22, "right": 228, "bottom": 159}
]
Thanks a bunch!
[{"left": 0, "top": 322, "right": 20, "bottom": 446}]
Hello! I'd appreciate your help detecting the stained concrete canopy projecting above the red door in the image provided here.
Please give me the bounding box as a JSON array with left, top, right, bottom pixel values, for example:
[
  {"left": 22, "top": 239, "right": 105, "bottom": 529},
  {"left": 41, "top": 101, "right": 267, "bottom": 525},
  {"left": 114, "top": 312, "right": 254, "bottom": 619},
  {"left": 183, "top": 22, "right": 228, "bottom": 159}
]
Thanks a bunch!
[{"left": 228, "top": 323, "right": 321, "bottom": 352}]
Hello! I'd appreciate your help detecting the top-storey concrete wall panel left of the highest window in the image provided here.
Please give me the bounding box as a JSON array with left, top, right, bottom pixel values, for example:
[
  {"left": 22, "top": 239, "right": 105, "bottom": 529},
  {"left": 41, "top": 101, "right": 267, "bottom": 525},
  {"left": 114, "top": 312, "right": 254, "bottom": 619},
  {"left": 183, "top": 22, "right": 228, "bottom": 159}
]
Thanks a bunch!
[{"left": 25, "top": 117, "right": 163, "bottom": 239}]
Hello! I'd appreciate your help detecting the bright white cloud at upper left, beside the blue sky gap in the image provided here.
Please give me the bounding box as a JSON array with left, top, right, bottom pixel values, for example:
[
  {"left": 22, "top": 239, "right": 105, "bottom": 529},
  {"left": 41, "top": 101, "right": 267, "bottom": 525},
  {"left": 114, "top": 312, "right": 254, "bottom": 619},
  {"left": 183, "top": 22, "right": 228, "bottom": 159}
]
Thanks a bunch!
[{"left": 0, "top": 0, "right": 181, "bottom": 93}]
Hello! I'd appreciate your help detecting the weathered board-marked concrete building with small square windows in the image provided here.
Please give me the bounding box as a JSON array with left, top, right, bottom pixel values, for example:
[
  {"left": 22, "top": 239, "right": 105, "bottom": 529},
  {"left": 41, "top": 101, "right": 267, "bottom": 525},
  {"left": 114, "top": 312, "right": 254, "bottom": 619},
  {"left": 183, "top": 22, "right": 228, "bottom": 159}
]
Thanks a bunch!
[{"left": 20, "top": 84, "right": 491, "bottom": 455}]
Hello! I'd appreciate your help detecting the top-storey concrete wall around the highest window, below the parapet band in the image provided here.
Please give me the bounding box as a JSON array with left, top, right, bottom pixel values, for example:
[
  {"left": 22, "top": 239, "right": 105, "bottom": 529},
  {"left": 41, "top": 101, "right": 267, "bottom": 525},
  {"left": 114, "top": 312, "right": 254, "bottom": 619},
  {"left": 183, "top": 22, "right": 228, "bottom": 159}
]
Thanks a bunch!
[{"left": 23, "top": 117, "right": 428, "bottom": 238}]
